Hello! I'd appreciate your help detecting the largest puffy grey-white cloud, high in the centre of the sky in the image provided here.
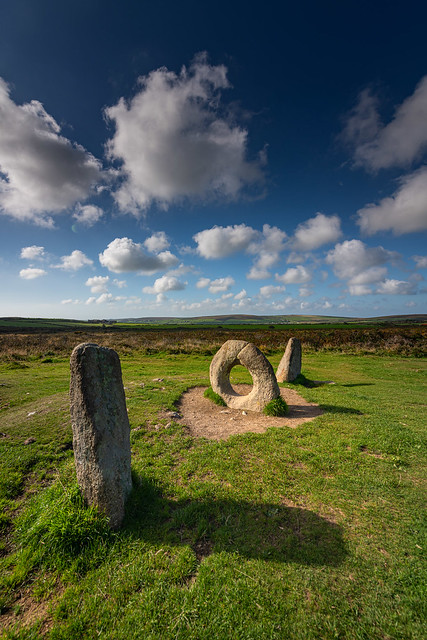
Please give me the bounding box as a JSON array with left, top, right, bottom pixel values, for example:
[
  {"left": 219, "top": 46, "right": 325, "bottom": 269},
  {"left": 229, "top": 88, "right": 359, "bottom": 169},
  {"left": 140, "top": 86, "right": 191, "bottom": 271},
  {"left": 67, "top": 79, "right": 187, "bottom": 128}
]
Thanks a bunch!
[{"left": 105, "top": 55, "right": 262, "bottom": 215}]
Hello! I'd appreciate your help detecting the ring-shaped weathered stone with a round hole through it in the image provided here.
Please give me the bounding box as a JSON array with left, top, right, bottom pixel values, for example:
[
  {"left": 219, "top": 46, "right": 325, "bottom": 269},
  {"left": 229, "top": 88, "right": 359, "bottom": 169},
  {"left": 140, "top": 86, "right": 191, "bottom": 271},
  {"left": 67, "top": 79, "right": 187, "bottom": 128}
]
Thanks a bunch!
[{"left": 209, "top": 340, "right": 280, "bottom": 412}]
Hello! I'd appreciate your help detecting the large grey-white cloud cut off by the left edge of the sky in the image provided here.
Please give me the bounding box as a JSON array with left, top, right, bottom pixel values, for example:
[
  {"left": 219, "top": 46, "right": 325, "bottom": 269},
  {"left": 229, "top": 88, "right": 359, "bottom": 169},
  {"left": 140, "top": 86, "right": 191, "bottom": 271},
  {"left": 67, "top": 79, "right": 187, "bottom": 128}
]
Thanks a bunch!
[{"left": 0, "top": 78, "right": 101, "bottom": 227}]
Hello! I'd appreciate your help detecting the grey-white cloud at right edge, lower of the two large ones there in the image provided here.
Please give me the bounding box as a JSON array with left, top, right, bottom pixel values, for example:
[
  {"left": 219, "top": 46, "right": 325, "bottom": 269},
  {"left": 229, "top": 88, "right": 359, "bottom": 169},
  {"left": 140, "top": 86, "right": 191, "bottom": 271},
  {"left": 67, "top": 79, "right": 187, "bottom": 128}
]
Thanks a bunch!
[{"left": 357, "top": 167, "right": 427, "bottom": 235}]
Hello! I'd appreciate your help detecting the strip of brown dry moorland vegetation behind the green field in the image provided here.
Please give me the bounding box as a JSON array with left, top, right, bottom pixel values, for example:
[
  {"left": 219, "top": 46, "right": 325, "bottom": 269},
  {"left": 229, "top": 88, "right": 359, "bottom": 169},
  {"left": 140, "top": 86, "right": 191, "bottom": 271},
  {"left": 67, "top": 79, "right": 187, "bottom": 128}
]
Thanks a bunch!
[{"left": 0, "top": 325, "right": 427, "bottom": 362}]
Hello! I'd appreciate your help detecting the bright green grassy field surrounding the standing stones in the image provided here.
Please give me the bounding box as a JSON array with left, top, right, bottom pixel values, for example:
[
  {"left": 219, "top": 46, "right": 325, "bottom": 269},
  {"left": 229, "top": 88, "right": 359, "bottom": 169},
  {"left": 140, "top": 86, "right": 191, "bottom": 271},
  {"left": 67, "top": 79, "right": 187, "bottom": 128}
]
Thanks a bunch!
[{"left": 0, "top": 334, "right": 427, "bottom": 640}]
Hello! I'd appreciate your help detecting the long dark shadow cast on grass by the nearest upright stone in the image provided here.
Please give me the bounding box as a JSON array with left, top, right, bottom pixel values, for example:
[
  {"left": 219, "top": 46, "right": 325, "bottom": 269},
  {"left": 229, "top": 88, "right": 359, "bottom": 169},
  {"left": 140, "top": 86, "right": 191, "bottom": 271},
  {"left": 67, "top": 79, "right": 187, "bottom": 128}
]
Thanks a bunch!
[{"left": 123, "top": 474, "right": 347, "bottom": 566}]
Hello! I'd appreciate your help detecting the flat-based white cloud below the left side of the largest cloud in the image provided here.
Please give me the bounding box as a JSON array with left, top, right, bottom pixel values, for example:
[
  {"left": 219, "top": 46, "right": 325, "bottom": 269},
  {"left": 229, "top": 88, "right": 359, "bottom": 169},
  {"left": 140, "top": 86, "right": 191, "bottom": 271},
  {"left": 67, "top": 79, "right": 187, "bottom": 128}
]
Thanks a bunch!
[{"left": 99, "top": 238, "right": 179, "bottom": 275}]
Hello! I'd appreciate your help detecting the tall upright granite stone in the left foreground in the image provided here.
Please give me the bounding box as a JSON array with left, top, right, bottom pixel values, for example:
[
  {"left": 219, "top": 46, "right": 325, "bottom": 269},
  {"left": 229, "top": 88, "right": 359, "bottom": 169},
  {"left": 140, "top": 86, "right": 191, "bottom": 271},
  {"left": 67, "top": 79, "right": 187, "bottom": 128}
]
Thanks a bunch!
[{"left": 70, "top": 342, "right": 132, "bottom": 529}]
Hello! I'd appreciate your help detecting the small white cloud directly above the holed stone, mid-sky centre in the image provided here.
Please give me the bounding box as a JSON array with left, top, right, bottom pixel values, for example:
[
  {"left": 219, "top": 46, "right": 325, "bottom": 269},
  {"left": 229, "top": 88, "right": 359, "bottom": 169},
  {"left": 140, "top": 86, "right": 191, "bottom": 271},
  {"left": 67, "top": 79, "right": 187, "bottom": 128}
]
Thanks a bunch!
[{"left": 193, "top": 224, "right": 259, "bottom": 258}]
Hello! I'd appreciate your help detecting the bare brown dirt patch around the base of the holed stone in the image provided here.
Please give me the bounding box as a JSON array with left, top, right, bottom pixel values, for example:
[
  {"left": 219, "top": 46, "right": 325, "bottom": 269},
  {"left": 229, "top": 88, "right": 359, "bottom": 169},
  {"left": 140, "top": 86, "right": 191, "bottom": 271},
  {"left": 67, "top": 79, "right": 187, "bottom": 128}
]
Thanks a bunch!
[{"left": 174, "top": 384, "right": 323, "bottom": 440}]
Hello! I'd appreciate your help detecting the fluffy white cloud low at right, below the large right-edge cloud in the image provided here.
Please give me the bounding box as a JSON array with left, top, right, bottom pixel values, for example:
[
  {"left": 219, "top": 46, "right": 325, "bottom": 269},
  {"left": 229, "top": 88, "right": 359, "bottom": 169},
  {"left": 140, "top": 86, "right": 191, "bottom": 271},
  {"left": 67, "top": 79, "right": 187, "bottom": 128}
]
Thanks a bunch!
[{"left": 326, "top": 240, "right": 399, "bottom": 295}]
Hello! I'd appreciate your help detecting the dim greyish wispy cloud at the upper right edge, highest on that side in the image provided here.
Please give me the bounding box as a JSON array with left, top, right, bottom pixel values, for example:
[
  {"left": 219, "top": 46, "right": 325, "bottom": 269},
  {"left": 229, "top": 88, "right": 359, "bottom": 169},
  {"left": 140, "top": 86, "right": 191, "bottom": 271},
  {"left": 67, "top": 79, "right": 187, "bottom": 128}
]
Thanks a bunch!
[{"left": 342, "top": 76, "right": 427, "bottom": 171}]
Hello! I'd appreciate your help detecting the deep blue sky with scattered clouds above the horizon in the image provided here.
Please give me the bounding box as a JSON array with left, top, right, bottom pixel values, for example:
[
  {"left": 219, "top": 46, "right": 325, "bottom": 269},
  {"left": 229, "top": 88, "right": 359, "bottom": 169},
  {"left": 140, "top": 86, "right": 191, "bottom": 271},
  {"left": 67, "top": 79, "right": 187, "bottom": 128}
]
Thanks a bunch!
[{"left": 0, "top": 0, "right": 427, "bottom": 319}]
